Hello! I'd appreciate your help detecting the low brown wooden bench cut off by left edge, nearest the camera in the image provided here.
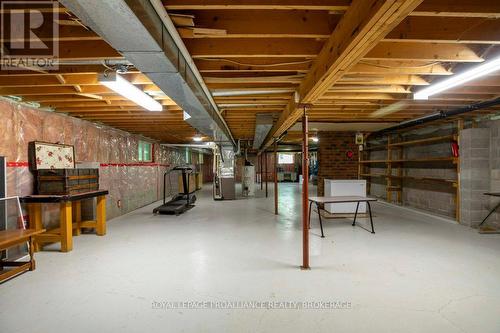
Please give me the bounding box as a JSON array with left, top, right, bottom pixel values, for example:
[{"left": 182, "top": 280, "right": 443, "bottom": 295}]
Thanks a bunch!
[{"left": 0, "top": 229, "right": 45, "bottom": 283}]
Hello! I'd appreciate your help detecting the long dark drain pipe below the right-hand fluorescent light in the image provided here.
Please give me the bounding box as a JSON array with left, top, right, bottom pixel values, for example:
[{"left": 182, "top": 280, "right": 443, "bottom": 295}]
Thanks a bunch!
[{"left": 373, "top": 97, "right": 500, "bottom": 134}]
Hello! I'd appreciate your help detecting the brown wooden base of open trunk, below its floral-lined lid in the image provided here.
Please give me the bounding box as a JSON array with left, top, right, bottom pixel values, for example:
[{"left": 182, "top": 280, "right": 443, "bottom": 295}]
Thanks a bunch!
[{"left": 36, "top": 169, "right": 99, "bottom": 195}]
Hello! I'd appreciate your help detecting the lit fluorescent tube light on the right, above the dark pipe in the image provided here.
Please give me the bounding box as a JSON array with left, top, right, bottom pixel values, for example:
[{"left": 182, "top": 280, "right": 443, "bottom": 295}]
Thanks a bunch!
[{"left": 413, "top": 58, "right": 500, "bottom": 100}]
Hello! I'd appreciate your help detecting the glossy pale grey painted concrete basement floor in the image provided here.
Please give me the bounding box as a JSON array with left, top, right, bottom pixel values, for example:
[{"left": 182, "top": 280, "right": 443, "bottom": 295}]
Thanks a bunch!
[{"left": 0, "top": 184, "right": 500, "bottom": 333}]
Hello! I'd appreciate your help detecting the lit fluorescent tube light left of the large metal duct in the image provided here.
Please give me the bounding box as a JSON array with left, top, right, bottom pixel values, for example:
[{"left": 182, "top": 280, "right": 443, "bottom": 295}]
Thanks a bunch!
[{"left": 99, "top": 73, "right": 163, "bottom": 111}]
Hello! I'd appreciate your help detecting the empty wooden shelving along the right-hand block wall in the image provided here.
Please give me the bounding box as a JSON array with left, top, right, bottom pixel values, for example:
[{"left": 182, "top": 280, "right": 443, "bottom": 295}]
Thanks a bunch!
[{"left": 358, "top": 120, "right": 463, "bottom": 220}]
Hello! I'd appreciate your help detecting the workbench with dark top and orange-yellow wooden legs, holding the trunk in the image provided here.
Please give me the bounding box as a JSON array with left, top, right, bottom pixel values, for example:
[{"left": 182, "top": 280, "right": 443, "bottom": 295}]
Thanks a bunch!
[{"left": 20, "top": 190, "right": 109, "bottom": 252}]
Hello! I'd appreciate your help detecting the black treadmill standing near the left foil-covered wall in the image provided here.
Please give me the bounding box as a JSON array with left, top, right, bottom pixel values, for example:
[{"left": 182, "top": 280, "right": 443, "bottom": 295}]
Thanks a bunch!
[{"left": 153, "top": 166, "right": 196, "bottom": 216}]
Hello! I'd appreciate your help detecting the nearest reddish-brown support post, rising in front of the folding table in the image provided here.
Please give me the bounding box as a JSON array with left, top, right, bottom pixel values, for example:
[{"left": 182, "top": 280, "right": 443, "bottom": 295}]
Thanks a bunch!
[{"left": 301, "top": 108, "right": 310, "bottom": 269}]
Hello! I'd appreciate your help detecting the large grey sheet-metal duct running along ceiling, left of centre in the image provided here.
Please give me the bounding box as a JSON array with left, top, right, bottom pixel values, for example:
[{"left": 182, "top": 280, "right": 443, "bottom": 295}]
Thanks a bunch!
[{"left": 60, "top": 0, "right": 235, "bottom": 146}]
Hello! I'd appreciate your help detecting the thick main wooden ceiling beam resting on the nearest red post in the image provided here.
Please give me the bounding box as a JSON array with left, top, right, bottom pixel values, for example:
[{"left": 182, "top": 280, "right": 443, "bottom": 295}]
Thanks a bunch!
[{"left": 262, "top": 0, "right": 422, "bottom": 149}]
